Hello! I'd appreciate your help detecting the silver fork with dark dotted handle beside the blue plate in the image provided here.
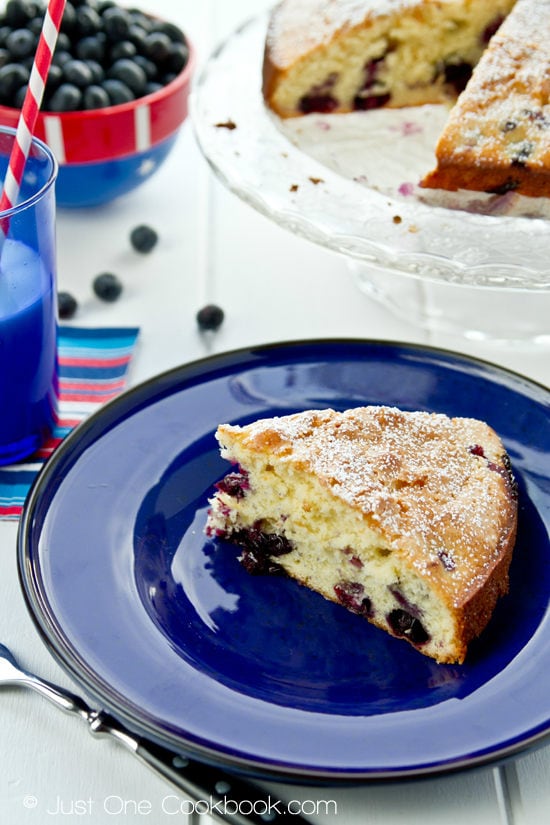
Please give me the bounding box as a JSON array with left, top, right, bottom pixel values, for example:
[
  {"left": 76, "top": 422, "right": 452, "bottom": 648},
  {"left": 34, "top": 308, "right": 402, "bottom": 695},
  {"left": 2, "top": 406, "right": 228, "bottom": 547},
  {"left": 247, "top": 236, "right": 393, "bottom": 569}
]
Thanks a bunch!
[{"left": 0, "top": 643, "right": 306, "bottom": 825}]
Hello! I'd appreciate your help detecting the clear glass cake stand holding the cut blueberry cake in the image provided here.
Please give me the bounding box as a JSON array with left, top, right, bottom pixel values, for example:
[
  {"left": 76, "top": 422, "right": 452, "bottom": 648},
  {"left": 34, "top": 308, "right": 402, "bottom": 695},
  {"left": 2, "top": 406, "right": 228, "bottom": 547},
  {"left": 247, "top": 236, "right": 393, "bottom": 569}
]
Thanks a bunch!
[{"left": 191, "top": 15, "right": 550, "bottom": 344}]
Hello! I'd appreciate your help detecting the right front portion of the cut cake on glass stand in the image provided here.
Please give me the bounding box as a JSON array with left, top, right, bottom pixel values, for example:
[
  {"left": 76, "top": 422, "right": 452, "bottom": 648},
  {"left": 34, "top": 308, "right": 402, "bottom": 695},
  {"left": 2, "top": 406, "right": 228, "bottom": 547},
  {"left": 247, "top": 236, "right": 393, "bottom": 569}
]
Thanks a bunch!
[{"left": 422, "top": 0, "right": 550, "bottom": 197}]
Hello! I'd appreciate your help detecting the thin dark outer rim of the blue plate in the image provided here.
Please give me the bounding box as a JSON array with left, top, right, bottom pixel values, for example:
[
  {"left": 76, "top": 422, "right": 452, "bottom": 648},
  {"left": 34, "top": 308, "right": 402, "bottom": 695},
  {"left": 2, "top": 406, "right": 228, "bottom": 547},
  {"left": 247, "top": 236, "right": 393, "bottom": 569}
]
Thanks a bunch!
[{"left": 18, "top": 338, "right": 550, "bottom": 783}]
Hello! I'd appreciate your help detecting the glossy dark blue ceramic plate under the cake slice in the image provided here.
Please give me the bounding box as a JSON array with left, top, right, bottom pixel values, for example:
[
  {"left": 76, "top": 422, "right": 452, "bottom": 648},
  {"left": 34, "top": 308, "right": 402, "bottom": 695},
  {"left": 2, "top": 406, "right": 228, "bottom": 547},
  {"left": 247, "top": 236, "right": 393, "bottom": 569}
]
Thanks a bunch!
[{"left": 19, "top": 340, "right": 550, "bottom": 782}]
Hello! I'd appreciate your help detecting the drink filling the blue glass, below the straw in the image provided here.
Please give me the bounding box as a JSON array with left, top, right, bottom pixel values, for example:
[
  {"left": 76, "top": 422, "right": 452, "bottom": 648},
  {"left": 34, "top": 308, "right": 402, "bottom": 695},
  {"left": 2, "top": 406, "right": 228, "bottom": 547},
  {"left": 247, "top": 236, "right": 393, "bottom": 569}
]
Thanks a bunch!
[{"left": 0, "top": 239, "right": 57, "bottom": 464}]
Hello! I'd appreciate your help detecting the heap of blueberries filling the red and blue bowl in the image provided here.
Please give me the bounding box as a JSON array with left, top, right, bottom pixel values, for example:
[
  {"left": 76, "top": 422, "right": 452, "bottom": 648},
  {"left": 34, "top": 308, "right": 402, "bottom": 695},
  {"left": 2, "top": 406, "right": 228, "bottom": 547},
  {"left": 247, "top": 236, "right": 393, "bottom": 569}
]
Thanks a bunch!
[{"left": 0, "top": 0, "right": 189, "bottom": 112}]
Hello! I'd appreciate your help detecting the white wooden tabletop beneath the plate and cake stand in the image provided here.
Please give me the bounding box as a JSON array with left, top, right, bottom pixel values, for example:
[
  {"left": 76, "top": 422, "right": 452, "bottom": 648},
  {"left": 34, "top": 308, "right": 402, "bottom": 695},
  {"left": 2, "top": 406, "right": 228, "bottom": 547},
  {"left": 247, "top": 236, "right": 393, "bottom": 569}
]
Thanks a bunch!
[{"left": 0, "top": 0, "right": 550, "bottom": 825}]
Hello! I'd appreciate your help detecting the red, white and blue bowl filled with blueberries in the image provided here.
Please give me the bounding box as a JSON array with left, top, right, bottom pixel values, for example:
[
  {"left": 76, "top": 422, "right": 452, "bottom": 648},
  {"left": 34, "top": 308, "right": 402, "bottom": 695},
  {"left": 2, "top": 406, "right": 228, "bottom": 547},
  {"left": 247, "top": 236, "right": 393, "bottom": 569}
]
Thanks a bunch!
[{"left": 0, "top": 0, "right": 194, "bottom": 207}]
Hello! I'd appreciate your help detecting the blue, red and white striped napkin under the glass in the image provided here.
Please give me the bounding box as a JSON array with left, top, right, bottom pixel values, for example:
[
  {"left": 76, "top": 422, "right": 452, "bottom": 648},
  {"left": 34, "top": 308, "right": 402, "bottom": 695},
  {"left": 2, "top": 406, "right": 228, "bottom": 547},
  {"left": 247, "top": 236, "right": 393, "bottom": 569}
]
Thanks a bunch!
[{"left": 0, "top": 327, "right": 139, "bottom": 520}]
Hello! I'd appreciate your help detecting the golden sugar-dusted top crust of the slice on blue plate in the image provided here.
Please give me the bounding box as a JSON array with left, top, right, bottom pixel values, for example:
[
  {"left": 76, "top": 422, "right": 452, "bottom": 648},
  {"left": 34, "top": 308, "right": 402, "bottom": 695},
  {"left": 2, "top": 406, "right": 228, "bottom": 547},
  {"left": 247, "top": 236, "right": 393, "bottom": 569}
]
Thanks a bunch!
[{"left": 218, "top": 406, "right": 517, "bottom": 661}]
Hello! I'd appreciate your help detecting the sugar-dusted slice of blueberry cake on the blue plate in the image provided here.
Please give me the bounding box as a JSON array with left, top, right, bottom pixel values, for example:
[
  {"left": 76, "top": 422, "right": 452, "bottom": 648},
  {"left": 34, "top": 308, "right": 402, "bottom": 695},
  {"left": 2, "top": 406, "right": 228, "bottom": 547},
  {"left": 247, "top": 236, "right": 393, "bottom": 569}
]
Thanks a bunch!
[{"left": 206, "top": 406, "right": 517, "bottom": 662}]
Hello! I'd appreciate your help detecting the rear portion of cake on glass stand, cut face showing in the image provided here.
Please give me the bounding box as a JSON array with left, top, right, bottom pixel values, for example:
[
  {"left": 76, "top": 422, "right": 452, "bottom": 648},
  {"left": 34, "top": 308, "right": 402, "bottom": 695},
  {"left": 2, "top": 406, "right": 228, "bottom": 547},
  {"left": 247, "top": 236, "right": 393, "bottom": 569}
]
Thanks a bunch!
[{"left": 263, "top": 0, "right": 515, "bottom": 117}]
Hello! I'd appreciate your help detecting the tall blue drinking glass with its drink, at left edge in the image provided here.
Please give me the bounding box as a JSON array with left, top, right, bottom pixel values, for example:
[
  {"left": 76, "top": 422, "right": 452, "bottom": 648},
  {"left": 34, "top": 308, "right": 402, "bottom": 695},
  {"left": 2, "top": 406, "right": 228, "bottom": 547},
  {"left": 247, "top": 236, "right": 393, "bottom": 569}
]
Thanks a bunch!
[{"left": 0, "top": 128, "right": 57, "bottom": 464}]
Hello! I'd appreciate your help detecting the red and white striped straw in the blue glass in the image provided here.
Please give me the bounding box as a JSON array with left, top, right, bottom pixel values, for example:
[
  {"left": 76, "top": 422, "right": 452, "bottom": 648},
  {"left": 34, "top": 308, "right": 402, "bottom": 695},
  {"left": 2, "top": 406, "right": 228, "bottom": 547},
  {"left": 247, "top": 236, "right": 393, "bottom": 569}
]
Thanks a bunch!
[{"left": 0, "top": 0, "right": 65, "bottom": 216}]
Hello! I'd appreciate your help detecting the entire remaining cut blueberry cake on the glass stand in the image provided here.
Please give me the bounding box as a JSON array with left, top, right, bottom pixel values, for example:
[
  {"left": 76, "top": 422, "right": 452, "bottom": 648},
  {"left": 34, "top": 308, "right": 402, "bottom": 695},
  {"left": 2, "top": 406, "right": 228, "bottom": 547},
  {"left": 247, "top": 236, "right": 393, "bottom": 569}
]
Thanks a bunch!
[{"left": 263, "top": 0, "right": 550, "bottom": 197}]
